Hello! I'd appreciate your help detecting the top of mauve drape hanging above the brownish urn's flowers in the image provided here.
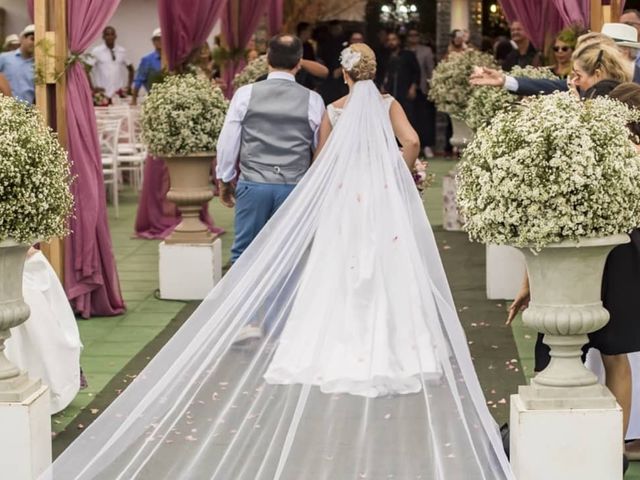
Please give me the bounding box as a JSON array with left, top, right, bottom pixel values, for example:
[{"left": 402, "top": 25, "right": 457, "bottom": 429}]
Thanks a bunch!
[{"left": 158, "top": 0, "right": 228, "bottom": 70}]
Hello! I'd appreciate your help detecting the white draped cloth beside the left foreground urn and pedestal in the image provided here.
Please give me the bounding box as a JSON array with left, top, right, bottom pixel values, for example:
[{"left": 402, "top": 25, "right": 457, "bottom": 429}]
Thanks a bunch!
[{"left": 5, "top": 248, "right": 82, "bottom": 414}]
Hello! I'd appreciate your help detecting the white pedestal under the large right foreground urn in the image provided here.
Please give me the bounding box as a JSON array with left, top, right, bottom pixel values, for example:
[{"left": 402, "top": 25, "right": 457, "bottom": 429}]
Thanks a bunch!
[{"left": 510, "top": 394, "right": 622, "bottom": 480}]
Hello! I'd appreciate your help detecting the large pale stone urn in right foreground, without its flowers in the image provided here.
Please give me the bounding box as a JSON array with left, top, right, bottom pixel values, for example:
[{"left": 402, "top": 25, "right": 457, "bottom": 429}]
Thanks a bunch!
[{"left": 521, "top": 235, "right": 629, "bottom": 398}]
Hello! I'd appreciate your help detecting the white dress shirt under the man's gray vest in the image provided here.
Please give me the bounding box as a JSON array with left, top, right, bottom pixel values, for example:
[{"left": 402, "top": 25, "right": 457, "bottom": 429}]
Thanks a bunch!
[{"left": 216, "top": 72, "right": 325, "bottom": 183}]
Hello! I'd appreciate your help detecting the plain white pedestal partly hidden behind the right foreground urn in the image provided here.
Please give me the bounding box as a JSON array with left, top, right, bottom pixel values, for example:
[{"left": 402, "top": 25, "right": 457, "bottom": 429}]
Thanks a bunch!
[{"left": 486, "top": 245, "right": 526, "bottom": 300}]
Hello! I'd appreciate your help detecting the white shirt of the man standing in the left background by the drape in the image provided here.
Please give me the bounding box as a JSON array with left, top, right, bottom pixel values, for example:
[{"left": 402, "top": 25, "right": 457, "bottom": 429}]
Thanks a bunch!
[{"left": 87, "top": 43, "right": 131, "bottom": 98}]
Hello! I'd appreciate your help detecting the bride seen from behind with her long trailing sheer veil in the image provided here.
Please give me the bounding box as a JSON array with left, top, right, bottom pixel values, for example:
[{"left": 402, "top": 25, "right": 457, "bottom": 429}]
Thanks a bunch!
[{"left": 46, "top": 44, "right": 513, "bottom": 480}]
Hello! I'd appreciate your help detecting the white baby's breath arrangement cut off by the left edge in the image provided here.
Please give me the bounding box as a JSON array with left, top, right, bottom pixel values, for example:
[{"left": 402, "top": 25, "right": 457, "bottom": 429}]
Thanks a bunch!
[{"left": 0, "top": 95, "right": 73, "bottom": 243}]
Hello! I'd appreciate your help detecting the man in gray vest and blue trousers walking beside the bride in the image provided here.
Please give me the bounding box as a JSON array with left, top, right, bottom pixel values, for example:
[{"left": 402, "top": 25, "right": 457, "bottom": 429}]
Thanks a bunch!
[{"left": 216, "top": 35, "right": 324, "bottom": 262}]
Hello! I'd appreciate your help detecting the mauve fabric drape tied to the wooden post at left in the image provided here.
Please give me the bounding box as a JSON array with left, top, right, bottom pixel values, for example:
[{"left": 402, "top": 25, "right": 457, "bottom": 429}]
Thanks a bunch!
[{"left": 64, "top": 0, "right": 125, "bottom": 318}]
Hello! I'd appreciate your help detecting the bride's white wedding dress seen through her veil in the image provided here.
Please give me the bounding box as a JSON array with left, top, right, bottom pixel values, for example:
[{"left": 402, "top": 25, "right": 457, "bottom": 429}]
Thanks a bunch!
[{"left": 265, "top": 96, "right": 441, "bottom": 397}]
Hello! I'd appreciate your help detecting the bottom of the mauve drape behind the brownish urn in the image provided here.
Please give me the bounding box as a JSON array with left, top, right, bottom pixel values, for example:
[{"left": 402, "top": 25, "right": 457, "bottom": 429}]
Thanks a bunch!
[{"left": 135, "top": 155, "right": 224, "bottom": 239}]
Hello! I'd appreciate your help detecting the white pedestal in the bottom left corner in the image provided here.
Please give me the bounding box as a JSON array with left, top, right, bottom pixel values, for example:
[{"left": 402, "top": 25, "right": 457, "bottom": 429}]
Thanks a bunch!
[{"left": 0, "top": 381, "right": 51, "bottom": 480}]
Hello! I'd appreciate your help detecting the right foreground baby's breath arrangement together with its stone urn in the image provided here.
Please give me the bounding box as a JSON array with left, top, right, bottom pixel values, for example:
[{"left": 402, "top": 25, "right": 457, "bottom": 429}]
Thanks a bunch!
[{"left": 458, "top": 92, "right": 640, "bottom": 394}]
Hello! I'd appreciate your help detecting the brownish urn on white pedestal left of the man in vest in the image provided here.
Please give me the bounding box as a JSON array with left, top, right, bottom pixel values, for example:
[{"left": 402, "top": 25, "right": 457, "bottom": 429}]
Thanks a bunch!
[{"left": 162, "top": 152, "right": 214, "bottom": 244}]
